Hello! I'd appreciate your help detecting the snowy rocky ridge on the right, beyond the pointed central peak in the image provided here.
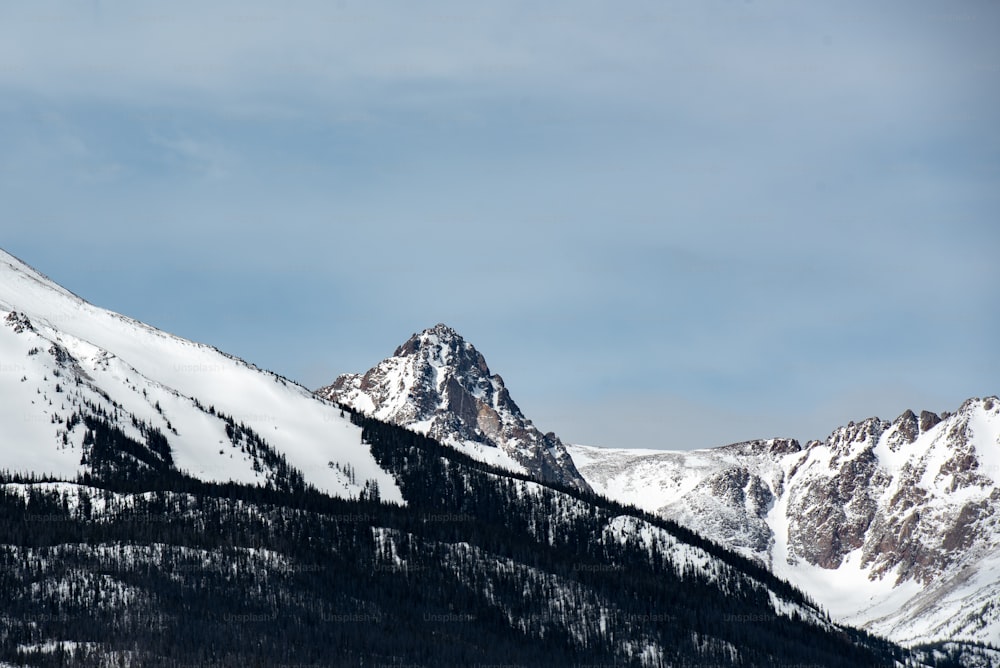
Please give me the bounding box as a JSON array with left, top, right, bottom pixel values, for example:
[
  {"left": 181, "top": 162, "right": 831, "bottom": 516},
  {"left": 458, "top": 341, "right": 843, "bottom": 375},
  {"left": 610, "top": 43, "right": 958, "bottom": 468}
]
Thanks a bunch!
[{"left": 568, "top": 397, "right": 1000, "bottom": 645}]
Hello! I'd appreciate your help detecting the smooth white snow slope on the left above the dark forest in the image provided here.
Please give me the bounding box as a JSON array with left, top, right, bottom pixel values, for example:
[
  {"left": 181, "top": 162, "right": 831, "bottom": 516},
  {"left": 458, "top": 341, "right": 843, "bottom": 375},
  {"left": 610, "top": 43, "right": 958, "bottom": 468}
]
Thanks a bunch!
[{"left": 0, "top": 251, "right": 402, "bottom": 501}]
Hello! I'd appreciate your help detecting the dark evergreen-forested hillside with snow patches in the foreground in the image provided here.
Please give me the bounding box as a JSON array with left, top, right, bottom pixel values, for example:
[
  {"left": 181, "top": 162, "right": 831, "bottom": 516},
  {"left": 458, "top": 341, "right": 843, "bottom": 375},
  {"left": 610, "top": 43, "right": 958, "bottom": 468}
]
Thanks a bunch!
[{"left": 0, "top": 416, "right": 948, "bottom": 666}]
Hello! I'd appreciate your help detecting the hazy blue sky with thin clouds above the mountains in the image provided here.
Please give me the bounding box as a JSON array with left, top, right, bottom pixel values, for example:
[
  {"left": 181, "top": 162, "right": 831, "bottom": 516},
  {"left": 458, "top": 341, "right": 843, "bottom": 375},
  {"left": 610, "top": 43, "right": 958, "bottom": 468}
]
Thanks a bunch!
[{"left": 0, "top": 0, "right": 1000, "bottom": 448}]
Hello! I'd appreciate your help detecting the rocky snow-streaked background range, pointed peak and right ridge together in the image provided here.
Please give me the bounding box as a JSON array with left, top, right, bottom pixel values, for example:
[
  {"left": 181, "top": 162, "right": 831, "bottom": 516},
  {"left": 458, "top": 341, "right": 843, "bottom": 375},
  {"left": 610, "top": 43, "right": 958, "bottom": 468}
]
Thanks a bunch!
[{"left": 318, "top": 316, "right": 1000, "bottom": 644}]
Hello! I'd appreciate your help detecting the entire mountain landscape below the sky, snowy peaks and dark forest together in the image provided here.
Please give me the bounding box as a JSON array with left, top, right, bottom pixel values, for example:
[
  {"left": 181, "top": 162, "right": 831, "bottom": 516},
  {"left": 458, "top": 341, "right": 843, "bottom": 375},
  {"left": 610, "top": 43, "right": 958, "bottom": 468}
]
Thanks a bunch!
[{"left": 0, "top": 251, "right": 1000, "bottom": 666}]
